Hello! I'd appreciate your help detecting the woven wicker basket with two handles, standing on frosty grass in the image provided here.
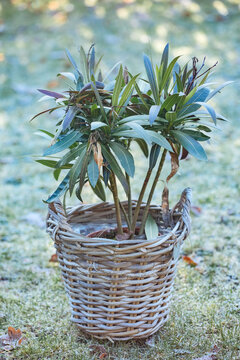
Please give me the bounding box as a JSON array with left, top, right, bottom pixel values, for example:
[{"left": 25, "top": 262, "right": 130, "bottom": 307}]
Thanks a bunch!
[{"left": 47, "top": 188, "right": 191, "bottom": 340}]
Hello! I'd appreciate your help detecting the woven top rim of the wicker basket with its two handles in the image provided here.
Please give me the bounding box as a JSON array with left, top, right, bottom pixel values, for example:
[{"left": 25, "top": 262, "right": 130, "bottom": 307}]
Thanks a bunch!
[{"left": 47, "top": 188, "right": 191, "bottom": 253}]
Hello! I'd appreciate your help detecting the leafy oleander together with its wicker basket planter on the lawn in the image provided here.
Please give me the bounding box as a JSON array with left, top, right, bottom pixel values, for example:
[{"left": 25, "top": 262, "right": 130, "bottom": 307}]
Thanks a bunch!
[{"left": 31, "top": 45, "right": 229, "bottom": 340}]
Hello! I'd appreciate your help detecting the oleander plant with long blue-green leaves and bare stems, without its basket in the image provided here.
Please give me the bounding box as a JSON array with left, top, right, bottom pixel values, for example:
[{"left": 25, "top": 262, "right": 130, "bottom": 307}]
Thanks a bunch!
[{"left": 34, "top": 44, "right": 230, "bottom": 238}]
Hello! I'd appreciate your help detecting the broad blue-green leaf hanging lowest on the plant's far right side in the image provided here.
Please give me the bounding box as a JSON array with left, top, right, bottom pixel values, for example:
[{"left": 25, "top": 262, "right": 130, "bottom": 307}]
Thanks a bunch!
[{"left": 171, "top": 130, "right": 207, "bottom": 161}]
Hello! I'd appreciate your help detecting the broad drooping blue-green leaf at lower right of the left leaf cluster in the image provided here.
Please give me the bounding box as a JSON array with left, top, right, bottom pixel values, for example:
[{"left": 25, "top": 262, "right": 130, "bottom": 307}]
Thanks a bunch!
[{"left": 109, "top": 142, "right": 135, "bottom": 177}]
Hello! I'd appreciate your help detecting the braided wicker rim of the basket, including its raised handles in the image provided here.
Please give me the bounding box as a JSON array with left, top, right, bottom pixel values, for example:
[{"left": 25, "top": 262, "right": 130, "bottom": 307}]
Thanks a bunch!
[{"left": 47, "top": 188, "right": 191, "bottom": 249}]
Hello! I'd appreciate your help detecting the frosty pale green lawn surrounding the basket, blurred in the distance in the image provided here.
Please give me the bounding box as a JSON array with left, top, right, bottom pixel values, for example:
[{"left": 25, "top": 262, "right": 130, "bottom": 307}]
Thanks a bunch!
[{"left": 0, "top": 0, "right": 240, "bottom": 360}]
